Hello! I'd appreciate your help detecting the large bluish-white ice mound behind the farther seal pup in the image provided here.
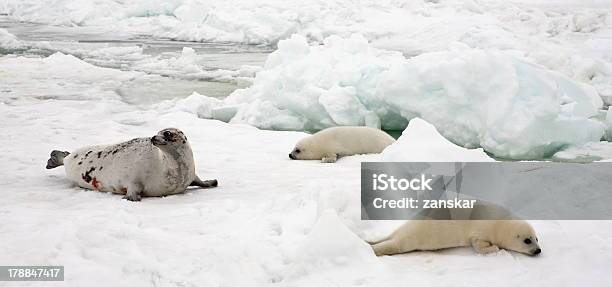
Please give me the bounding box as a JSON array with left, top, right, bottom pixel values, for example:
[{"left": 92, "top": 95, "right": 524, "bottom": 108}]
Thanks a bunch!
[{"left": 200, "top": 34, "right": 604, "bottom": 159}]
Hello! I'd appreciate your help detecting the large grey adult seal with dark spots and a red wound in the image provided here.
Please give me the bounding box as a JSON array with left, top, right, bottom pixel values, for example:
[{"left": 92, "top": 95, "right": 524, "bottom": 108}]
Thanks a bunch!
[{"left": 47, "top": 128, "right": 217, "bottom": 201}]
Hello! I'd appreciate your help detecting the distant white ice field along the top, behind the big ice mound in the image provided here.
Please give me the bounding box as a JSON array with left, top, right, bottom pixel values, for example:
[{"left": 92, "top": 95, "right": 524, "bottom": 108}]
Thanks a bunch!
[{"left": 0, "top": 0, "right": 609, "bottom": 50}]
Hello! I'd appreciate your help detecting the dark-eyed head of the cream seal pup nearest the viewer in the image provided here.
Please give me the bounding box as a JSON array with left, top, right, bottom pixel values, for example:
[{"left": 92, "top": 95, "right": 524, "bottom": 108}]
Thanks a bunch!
[{"left": 500, "top": 220, "right": 542, "bottom": 256}]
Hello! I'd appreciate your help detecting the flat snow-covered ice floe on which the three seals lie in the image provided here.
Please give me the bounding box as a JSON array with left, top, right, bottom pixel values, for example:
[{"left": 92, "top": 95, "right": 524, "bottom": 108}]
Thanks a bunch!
[{"left": 0, "top": 46, "right": 612, "bottom": 286}]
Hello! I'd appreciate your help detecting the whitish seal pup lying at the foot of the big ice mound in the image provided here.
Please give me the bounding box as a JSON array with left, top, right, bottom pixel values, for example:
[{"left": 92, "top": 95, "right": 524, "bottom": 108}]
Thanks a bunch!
[{"left": 289, "top": 126, "right": 395, "bottom": 163}]
